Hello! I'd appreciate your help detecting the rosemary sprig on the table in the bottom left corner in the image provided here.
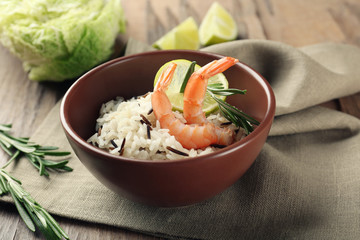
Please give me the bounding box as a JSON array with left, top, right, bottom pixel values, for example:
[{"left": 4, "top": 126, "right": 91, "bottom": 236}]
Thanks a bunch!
[{"left": 0, "top": 168, "right": 69, "bottom": 239}]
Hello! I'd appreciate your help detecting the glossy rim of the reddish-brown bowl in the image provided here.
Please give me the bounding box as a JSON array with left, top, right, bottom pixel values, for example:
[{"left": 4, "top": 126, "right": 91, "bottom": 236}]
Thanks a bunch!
[{"left": 60, "top": 50, "right": 276, "bottom": 164}]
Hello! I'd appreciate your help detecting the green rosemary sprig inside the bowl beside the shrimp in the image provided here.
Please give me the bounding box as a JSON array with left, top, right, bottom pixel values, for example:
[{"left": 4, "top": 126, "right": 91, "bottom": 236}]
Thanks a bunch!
[{"left": 207, "top": 83, "right": 260, "bottom": 134}]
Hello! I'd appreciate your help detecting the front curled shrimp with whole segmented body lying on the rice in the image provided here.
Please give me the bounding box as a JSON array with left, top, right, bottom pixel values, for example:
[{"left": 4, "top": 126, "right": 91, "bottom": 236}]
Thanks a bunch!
[{"left": 151, "top": 63, "right": 233, "bottom": 149}]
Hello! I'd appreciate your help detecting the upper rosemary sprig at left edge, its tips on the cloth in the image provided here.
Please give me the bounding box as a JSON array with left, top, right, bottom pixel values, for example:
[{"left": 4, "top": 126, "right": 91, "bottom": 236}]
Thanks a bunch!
[{"left": 0, "top": 124, "right": 72, "bottom": 176}]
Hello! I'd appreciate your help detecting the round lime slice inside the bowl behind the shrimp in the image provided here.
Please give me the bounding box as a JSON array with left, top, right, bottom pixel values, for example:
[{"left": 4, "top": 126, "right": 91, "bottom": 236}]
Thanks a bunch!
[{"left": 154, "top": 59, "right": 229, "bottom": 115}]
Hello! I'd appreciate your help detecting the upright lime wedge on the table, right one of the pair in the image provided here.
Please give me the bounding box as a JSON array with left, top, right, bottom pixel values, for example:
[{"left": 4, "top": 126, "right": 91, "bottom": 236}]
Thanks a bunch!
[{"left": 199, "top": 2, "right": 238, "bottom": 46}]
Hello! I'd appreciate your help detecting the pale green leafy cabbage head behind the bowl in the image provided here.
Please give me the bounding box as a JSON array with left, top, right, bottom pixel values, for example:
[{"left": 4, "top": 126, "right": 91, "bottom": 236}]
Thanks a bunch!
[{"left": 0, "top": 0, "right": 125, "bottom": 81}]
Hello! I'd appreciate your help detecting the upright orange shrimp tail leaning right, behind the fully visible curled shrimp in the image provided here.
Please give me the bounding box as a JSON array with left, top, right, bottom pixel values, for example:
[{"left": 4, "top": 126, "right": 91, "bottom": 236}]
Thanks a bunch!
[{"left": 184, "top": 57, "right": 239, "bottom": 124}]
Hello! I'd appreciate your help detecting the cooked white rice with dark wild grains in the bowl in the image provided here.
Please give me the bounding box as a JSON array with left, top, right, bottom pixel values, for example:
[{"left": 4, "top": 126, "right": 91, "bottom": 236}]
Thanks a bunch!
[{"left": 88, "top": 93, "right": 245, "bottom": 160}]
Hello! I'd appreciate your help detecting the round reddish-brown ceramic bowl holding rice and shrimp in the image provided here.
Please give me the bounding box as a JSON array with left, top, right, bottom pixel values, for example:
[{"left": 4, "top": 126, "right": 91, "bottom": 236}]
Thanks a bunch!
[{"left": 60, "top": 50, "right": 275, "bottom": 207}]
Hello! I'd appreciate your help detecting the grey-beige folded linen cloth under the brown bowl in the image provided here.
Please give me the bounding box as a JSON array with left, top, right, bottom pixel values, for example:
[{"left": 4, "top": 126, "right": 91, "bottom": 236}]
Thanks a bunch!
[{"left": 2, "top": 40, "right": 360, "bottom": 239}]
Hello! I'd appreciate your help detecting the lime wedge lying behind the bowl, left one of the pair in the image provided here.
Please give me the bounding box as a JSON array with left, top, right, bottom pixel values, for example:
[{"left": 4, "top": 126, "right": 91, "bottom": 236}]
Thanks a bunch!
[{"left": 153, "top": 17, "right": 200, "bottom": 50}]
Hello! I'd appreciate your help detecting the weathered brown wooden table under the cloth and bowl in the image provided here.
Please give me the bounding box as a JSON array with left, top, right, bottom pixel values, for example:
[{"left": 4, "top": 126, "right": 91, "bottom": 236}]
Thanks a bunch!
[{"left": 0, "top": 0, "right": 360, "bottom": 239}]
